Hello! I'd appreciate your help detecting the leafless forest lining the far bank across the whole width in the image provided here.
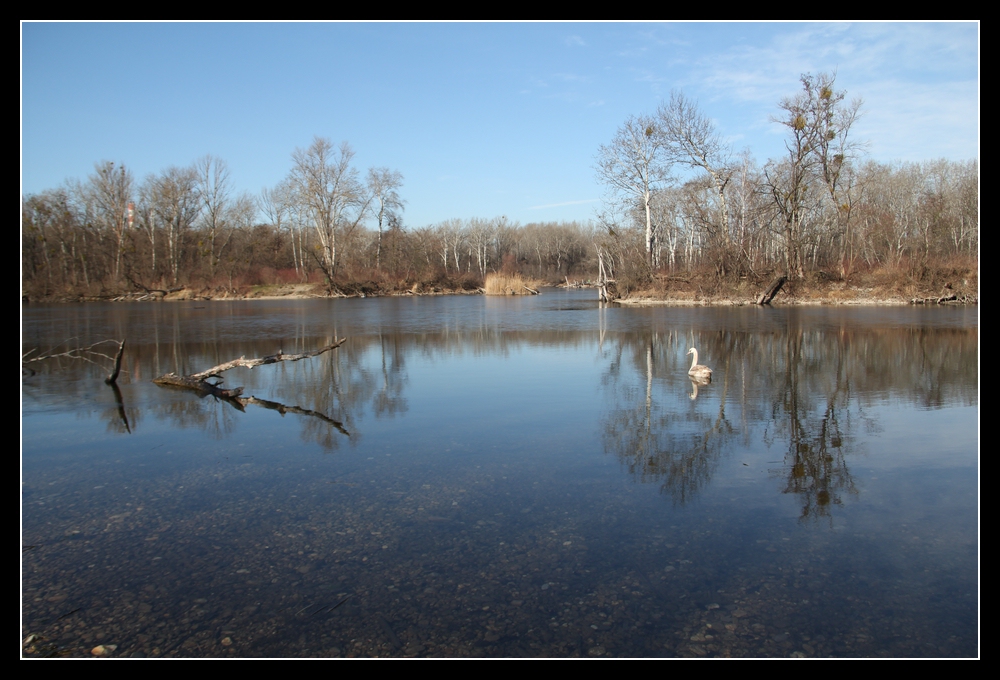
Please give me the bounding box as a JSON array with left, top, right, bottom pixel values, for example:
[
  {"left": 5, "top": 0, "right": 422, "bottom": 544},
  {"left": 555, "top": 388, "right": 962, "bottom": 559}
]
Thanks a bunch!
[{"left": 21, "top": 74, "right": 979, "bottom": 300}]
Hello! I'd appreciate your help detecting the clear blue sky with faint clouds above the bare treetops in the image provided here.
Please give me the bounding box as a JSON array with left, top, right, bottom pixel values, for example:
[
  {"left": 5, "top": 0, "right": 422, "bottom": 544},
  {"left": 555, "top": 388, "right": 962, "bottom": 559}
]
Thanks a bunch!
[{"left": 21, "top": 22, "right": 979, "bottom": 227}]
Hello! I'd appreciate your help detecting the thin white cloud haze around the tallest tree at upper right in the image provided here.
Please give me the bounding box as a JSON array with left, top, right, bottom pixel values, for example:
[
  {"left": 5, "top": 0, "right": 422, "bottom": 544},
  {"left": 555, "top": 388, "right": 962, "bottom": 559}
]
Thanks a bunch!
[{"left": 636, "top": 23, "right": 979, "bottom": 160}]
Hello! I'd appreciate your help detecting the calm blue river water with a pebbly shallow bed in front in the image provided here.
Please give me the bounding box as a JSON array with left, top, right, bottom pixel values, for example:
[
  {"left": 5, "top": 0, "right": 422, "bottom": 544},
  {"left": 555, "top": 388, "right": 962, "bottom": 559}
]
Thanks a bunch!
[{"left": 21, "top": 290, "right": 979, "bottom": 657}]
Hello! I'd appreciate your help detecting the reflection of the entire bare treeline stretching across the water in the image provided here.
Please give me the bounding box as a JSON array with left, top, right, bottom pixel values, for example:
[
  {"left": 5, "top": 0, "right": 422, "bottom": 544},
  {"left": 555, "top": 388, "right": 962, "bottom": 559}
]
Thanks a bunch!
[{"left": 22, "top": 301, "right": 978, "bottom": 484}]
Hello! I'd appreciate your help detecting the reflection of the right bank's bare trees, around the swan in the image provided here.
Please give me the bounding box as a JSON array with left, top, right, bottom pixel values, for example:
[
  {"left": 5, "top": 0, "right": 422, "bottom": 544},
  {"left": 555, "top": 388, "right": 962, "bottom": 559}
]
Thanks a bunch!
[{"left": 603, "top": 313, "right": 978, "bottom": 518}]
